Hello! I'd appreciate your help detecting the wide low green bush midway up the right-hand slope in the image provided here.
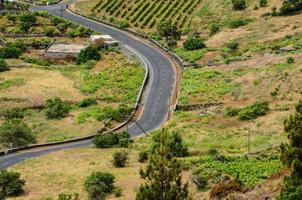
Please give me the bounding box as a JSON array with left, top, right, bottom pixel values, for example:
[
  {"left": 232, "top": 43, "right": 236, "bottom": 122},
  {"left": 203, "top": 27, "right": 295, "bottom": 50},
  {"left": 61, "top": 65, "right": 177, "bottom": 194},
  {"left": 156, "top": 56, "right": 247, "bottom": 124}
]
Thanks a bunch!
[{"left": 238, "top": 102, "right": 269, "bottom": 121}]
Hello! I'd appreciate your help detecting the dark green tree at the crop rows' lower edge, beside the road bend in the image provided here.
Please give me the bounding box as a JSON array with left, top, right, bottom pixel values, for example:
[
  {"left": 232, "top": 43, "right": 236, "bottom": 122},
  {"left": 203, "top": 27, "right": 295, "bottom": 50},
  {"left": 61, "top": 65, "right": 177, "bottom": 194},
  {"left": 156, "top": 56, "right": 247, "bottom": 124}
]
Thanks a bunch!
[{"left": 157, "top": 21, "right": 181, "bottom": 47}]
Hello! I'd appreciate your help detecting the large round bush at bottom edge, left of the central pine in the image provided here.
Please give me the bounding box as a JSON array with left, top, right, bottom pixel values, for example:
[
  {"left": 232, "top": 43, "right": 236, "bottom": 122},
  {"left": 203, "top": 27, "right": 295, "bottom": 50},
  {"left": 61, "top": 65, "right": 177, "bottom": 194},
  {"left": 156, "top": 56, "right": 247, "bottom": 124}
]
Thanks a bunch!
[{"left": 84, "top": 172, "right": 115, "bottom": 200}]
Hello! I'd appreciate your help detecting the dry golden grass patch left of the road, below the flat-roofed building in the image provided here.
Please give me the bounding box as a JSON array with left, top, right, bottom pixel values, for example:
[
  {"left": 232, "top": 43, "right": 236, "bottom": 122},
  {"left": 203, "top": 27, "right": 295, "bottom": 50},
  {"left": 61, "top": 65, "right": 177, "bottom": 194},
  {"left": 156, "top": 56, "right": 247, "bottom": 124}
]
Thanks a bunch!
[{"left": 0, "top": 68, "right": 84, "bottom": 108}]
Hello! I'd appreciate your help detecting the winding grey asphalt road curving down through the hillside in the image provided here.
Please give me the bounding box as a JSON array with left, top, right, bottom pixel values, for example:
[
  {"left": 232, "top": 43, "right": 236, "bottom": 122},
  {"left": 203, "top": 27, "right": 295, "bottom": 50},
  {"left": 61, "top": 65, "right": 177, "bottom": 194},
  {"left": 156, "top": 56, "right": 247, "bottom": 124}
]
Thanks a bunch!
[{"left": 0, "top": 1, "right": 176, "bottom": 169}]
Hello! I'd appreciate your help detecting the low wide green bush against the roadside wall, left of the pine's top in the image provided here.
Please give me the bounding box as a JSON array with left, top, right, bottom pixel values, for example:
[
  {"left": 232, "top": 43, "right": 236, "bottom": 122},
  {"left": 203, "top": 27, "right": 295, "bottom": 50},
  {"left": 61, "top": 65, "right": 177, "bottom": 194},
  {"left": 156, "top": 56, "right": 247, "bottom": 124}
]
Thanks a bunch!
[{"left": 92, "top": 132, "right": 131, "bottom": 148}]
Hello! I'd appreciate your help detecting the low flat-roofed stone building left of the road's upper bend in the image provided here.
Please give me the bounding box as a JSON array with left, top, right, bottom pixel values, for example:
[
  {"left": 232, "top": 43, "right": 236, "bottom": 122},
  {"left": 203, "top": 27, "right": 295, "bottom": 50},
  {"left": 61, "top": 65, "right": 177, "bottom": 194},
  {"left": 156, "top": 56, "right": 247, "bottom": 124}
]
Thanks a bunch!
[{"left": 44, "top": 43, "right": 88, "bottom": 59}]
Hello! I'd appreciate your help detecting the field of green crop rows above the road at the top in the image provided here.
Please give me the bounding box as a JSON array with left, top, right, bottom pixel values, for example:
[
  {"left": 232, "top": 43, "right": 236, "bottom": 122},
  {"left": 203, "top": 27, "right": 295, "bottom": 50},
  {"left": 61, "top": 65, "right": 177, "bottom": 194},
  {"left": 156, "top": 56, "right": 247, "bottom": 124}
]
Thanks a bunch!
[{"left": 91, "top": 0, "right": 201, "bottom": 29}]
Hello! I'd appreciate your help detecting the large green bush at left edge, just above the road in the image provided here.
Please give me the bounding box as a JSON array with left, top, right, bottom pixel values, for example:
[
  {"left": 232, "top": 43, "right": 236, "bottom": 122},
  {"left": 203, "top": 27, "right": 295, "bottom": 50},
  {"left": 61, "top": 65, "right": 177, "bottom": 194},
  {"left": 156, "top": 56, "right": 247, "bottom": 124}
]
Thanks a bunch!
[{"left": 0, "top": 119, "right": 36, "bottom": 147}]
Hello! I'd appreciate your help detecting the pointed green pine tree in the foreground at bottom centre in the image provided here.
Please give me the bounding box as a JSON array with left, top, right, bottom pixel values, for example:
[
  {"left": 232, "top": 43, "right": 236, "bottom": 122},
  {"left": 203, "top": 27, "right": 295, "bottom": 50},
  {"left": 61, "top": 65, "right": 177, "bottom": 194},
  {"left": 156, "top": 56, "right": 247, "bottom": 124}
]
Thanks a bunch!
[{"left": 136, "top": 131, "right": 190, "bottom": 200}]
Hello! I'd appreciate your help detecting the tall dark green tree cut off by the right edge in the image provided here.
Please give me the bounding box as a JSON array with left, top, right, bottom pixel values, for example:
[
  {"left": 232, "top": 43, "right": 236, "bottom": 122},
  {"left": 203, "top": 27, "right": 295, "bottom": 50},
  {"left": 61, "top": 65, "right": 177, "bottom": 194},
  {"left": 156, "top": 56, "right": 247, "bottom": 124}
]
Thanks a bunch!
[{"left": 279, "top": 101, "right": 302, "bottom": 200}]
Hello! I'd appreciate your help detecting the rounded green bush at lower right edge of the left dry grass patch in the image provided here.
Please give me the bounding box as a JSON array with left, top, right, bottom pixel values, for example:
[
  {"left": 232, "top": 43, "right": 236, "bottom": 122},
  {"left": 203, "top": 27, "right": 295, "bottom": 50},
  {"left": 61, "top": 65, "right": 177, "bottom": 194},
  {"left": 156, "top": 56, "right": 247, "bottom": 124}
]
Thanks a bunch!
[{"left": 45, "top": 97, "right": 70, "bottom": 119}]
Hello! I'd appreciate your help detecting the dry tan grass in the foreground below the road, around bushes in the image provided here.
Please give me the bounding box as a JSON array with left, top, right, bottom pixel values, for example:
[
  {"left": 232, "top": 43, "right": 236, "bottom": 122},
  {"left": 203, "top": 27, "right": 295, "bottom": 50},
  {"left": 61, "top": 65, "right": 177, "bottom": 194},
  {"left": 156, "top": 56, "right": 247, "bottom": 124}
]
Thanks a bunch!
[{"left": 9, "top": 148, "right": 197, "bottom": 200}]
